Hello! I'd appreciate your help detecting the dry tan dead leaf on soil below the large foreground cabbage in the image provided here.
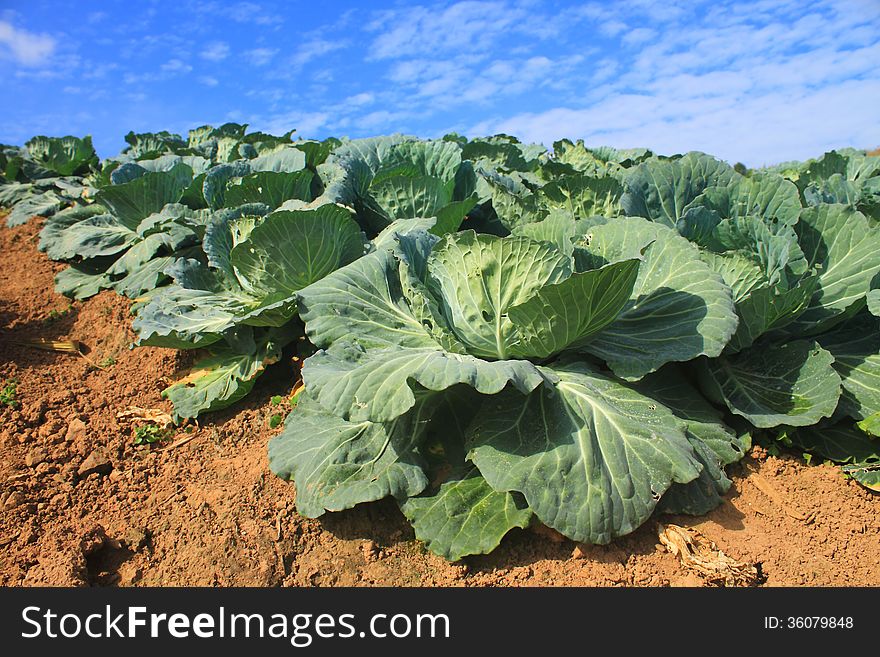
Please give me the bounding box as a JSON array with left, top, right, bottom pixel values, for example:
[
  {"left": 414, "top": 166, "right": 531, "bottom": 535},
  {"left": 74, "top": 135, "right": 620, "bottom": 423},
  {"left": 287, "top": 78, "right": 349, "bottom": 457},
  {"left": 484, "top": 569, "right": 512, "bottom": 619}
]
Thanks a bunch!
[{"left": 657, "top": 524, "right": 758, "bottom": 586}]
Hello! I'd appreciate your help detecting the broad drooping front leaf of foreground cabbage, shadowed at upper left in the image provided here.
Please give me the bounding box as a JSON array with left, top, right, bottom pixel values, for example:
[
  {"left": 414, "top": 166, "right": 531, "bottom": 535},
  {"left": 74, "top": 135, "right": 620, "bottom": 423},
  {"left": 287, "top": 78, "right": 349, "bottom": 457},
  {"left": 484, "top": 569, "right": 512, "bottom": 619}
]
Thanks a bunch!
[{"left": 469, "top": 363, "right": 702, "bottom": 543}]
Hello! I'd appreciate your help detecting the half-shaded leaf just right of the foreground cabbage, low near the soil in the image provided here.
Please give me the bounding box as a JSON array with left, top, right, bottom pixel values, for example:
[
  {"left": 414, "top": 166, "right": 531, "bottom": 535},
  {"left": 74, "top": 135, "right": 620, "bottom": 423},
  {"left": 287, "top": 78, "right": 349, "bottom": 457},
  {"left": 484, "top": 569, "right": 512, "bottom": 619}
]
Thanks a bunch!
[{"left": 700, "top": 340, "right": 840, "bottom": 428}]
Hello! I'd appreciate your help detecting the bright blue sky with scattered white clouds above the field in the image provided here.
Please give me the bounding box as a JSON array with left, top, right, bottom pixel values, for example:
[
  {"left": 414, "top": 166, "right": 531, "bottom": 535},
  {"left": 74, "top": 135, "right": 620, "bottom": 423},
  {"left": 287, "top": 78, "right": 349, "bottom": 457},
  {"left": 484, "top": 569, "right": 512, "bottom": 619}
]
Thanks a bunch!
[{"left": 0, "top": 0, "right": 880, "bottom": 166}]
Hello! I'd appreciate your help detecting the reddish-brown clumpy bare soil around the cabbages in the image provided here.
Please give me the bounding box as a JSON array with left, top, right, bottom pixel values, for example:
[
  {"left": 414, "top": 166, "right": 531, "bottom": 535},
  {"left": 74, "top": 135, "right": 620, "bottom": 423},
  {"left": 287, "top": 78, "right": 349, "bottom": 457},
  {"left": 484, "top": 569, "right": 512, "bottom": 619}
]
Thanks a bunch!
[{"left": 0, "top": 219, "right": 880, "bottom": 586}]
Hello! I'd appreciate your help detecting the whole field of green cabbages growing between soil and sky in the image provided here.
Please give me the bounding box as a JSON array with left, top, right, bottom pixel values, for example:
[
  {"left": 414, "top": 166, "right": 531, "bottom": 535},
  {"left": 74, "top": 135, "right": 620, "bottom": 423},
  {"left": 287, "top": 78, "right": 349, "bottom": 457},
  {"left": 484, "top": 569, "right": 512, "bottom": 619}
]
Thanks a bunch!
[{"left": 0, "top": 124, "right": 880, "bottom": 560}]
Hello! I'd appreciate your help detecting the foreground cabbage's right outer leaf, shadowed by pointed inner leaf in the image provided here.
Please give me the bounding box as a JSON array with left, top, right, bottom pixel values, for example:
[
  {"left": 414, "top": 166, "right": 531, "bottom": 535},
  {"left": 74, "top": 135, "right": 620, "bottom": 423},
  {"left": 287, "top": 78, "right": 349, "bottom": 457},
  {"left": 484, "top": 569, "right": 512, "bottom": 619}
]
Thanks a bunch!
[{"left": 575, "top": 217, "right": 737, "bottom": 379}]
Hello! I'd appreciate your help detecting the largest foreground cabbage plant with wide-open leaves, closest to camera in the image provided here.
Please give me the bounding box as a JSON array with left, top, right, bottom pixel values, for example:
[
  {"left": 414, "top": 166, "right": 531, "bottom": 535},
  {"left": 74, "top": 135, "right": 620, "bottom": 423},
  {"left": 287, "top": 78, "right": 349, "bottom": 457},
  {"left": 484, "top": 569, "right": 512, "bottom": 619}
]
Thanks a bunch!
[{"left": 269, "top": 215, "right": 742, "bottom": 559}]
